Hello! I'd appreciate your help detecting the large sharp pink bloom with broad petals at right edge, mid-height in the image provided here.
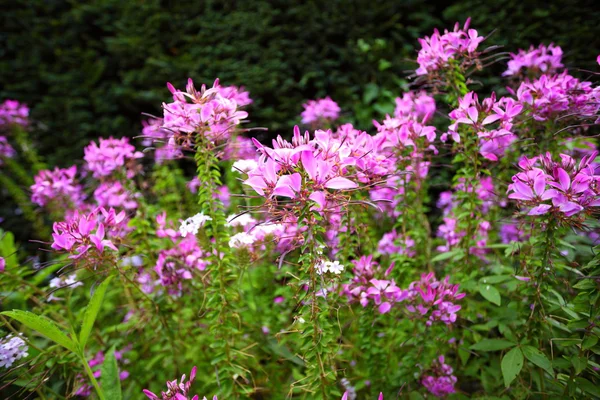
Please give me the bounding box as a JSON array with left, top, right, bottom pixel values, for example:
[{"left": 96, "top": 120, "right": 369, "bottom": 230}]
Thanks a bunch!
[{"left": 508, "top": 152, "right": 600, "bottom": 219}]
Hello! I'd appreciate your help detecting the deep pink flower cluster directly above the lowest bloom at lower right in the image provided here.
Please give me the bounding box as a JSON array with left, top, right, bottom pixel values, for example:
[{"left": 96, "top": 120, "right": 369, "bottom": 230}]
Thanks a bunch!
[{"left": 402, "top": 272, "right": 465, "bottom": 326}]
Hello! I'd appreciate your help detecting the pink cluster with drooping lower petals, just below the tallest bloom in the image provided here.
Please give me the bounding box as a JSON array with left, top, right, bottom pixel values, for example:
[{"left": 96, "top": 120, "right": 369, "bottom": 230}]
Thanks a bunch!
[{"left": 441, "top": 92, "right": 523, "bottom": 161}]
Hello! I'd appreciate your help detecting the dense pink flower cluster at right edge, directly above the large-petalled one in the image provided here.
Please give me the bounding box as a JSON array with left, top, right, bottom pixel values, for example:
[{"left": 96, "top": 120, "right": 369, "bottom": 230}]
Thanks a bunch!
[{"left": 516, "top": 71, "right": 600, "bottom": 124}]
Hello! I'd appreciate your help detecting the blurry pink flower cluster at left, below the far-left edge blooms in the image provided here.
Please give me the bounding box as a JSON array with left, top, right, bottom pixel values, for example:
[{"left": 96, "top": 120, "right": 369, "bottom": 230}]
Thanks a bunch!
[{"left": 31, "top": 165, "right": 85, "bottom": 209}]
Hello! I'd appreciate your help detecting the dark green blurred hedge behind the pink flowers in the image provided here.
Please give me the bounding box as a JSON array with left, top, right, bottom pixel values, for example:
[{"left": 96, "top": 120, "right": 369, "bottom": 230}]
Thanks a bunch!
[{"left": 0, "top": 0, "right": 600, "bottom": 166}]
